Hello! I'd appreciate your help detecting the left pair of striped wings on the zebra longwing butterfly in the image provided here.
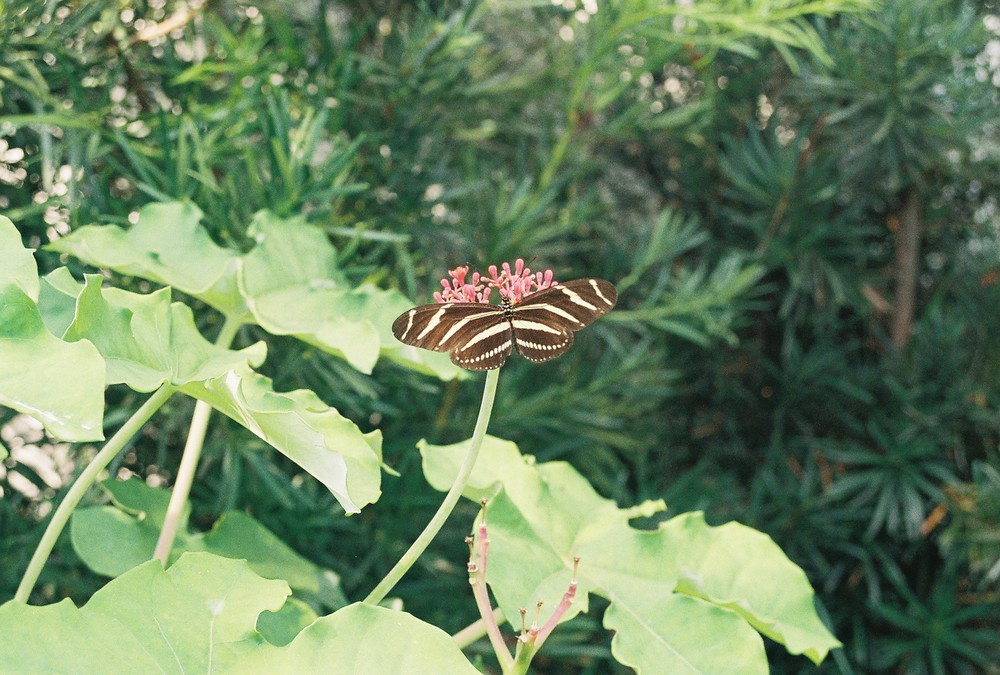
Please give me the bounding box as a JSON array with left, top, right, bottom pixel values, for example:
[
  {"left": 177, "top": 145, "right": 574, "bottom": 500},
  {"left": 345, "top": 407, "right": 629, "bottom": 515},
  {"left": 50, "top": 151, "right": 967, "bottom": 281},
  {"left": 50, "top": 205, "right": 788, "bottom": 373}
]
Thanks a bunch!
[{"left": 392, "top": 302, "right": 514, "bottom": 370}]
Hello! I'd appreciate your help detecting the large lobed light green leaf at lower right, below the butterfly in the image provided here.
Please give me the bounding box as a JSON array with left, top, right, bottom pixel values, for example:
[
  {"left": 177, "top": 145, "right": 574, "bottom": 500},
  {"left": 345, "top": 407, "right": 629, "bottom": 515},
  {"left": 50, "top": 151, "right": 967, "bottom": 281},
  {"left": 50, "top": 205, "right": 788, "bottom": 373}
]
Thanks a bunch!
[{"left": 421, "top": 437, "right": 840, "bottom": 672}]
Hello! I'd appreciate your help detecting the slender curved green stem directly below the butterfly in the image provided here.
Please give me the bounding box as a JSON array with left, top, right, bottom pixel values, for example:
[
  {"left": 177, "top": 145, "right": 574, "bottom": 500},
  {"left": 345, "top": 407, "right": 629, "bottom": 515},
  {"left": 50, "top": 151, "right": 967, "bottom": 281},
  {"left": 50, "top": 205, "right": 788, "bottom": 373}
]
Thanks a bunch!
[{"left": 365, "top": 368, "right": 500, "bottom": 605}]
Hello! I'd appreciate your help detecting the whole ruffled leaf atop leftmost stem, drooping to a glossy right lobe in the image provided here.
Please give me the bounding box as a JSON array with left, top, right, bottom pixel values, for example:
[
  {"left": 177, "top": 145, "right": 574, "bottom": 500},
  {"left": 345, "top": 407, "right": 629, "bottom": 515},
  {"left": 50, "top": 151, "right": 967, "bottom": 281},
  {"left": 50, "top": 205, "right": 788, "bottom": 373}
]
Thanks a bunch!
[{"left": 45, "top": 269, "right": 382, "bottom": 513}]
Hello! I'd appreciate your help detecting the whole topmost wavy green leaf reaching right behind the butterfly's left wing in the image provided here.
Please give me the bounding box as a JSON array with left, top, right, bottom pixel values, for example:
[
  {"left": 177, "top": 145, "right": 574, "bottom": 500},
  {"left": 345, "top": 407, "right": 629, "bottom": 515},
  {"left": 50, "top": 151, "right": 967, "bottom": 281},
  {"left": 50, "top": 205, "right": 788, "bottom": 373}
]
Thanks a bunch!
[{"left": 49, "top": 202, "right": 464, "bottom": 379}]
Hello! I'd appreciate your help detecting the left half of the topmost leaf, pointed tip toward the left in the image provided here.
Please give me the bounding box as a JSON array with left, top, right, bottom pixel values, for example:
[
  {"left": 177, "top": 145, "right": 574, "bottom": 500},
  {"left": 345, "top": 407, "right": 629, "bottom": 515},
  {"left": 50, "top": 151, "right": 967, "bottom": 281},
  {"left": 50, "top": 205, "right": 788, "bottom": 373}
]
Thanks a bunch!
[{"left": 47, "top": 202, "right": 249, "bottom": 321}]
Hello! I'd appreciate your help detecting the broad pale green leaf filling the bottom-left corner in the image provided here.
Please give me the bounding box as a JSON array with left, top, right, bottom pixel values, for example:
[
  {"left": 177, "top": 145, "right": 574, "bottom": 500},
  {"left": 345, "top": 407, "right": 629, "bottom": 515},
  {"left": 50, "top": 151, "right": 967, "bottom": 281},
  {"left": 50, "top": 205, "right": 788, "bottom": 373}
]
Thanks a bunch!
[{"left": 0, "top": 553, "right": 288, "bottom": 673}]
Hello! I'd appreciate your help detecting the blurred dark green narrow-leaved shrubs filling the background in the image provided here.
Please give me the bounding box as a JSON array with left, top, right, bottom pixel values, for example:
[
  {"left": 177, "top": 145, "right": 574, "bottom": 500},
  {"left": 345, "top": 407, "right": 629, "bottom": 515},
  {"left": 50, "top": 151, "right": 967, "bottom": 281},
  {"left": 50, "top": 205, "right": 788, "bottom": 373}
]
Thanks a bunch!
[{"left": 0, "top": 0, "right": 1000, "bottom": 673}]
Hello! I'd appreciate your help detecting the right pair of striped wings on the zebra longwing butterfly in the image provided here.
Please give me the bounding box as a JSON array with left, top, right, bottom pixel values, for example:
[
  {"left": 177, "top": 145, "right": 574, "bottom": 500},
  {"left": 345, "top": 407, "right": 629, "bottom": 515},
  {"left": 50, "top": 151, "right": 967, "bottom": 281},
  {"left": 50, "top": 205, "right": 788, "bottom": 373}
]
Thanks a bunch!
[{"left": 511, "top": 279, "right": 618, "bottom": 363}]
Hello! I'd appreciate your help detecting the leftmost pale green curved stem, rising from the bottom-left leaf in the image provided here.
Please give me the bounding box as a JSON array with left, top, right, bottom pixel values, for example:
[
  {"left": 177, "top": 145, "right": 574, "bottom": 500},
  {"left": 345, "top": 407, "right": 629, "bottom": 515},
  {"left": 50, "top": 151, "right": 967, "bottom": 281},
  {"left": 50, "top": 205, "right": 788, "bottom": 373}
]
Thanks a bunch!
[{"left": 14, "top": 384, "right": 177, "bottom": 602}]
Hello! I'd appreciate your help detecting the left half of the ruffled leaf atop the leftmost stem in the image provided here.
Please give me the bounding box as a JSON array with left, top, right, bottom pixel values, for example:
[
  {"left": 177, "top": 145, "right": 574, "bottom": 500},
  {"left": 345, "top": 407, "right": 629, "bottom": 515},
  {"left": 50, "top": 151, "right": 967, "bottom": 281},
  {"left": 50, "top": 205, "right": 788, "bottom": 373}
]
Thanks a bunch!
[{"left": 46, "top": 268, "right": 266, "bottom": 392}]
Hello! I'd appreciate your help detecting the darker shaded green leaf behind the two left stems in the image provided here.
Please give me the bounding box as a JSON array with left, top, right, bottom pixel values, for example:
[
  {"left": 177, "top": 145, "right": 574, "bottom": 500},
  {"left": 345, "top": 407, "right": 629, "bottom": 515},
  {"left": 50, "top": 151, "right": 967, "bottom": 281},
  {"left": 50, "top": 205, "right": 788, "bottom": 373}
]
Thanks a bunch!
[{"left": 71, "top": 478, "right": 347, "bottom": 609}]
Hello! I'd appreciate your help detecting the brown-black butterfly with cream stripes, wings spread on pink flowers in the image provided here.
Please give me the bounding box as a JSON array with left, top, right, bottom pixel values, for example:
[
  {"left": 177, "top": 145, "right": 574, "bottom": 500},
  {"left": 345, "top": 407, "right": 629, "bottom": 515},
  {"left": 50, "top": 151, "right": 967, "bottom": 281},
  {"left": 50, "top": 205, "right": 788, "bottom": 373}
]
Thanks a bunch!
[{"left": 392, "top": 279, "right": 618, "bottom": 370}]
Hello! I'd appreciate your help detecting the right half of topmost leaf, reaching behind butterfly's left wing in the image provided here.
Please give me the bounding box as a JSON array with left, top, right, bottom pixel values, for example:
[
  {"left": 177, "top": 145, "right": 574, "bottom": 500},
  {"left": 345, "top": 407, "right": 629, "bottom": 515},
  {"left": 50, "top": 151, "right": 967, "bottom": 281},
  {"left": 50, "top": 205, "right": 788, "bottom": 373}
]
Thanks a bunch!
[{"left": 240, "top": 212, "right": 462, "bottom": 379}]
